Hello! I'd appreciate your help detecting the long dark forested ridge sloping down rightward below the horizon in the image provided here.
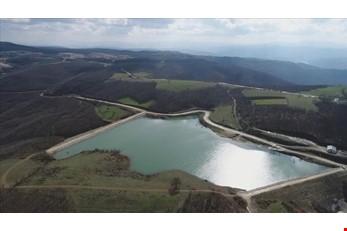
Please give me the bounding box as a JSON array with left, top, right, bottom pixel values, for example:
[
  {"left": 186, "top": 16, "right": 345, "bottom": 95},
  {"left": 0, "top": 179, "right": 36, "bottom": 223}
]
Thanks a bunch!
[{"left": 0, "top": 43, "right": 291, "bottom": 91}]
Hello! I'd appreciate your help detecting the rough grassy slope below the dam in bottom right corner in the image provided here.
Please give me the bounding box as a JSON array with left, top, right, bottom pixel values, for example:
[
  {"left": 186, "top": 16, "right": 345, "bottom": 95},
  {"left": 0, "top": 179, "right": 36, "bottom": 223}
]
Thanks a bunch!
[{"left": 252, "top": 171, "right": 347, "bottom": 212}]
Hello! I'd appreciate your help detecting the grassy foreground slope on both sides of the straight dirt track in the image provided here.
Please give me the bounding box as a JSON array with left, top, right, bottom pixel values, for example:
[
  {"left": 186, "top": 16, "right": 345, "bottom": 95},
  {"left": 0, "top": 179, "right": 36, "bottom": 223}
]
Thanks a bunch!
[{"left": 0, "top": 152, "right": 246, "bottom": 212}]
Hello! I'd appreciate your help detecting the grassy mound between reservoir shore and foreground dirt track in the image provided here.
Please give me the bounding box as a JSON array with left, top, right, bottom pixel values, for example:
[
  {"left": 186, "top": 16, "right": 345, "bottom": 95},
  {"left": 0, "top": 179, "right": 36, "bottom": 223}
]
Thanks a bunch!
[{"left": 21, "top": 153, "right": 228, "bottom": 190}]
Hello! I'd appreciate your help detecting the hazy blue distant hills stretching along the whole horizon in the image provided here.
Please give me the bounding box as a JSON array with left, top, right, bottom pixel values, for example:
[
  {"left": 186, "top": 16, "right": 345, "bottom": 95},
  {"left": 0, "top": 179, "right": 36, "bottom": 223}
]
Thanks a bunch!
[{"left": 0, "top": 42, "right": 347, "bottom": 88}]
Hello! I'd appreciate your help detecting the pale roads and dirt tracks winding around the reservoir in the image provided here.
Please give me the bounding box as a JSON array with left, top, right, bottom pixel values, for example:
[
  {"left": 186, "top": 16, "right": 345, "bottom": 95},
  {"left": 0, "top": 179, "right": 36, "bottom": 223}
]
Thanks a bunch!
[{"left": 0, "top": 92, "right": 346, "bottom": 210}]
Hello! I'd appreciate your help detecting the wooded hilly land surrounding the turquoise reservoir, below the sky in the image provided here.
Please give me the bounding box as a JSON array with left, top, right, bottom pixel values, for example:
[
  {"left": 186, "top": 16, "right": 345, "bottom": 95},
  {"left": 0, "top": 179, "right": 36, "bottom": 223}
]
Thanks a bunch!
[{"left": 0, "top": 42, "right": 347, "bottom": 212}]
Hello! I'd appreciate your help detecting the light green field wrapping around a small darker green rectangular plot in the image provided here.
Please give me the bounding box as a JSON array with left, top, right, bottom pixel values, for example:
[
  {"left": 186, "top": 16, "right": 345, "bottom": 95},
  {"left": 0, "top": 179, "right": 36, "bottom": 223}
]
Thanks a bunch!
[{"left": 242, "top": 89, "right": 318, "bottom": 112}]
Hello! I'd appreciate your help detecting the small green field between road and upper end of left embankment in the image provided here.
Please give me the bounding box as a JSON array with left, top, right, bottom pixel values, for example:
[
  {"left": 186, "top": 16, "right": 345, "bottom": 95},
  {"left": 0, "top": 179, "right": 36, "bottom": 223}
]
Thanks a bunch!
[{"left": 95, "top": 105, "right": 132, "bottom": 122}]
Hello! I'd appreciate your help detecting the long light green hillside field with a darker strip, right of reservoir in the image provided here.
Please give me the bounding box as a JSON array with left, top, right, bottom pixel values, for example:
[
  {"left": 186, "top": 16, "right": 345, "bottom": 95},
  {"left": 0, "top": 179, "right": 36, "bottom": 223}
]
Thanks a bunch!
[{"left": 242, "top": 89, "right": 318, "bottom": 111}]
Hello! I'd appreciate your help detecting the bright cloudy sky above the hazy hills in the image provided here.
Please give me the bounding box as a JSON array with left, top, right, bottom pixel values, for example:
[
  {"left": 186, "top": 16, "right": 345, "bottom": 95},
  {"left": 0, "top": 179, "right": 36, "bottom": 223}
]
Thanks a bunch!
[{"left": 0, "top": 18, "right": 347, "bottom": 50}]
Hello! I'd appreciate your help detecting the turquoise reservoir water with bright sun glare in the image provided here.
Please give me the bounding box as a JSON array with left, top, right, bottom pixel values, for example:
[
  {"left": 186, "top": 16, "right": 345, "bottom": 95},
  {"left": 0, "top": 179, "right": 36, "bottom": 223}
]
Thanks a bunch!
[{"left": 55, "top": 117, "right": 327, "bottom": 190}]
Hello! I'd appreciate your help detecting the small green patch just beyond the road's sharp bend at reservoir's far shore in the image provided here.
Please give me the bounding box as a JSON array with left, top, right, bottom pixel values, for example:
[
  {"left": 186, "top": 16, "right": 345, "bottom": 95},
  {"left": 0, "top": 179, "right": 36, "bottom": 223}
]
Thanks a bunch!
[{"left": 210, "top": 105, "right": 240, "bottom": 129}]
